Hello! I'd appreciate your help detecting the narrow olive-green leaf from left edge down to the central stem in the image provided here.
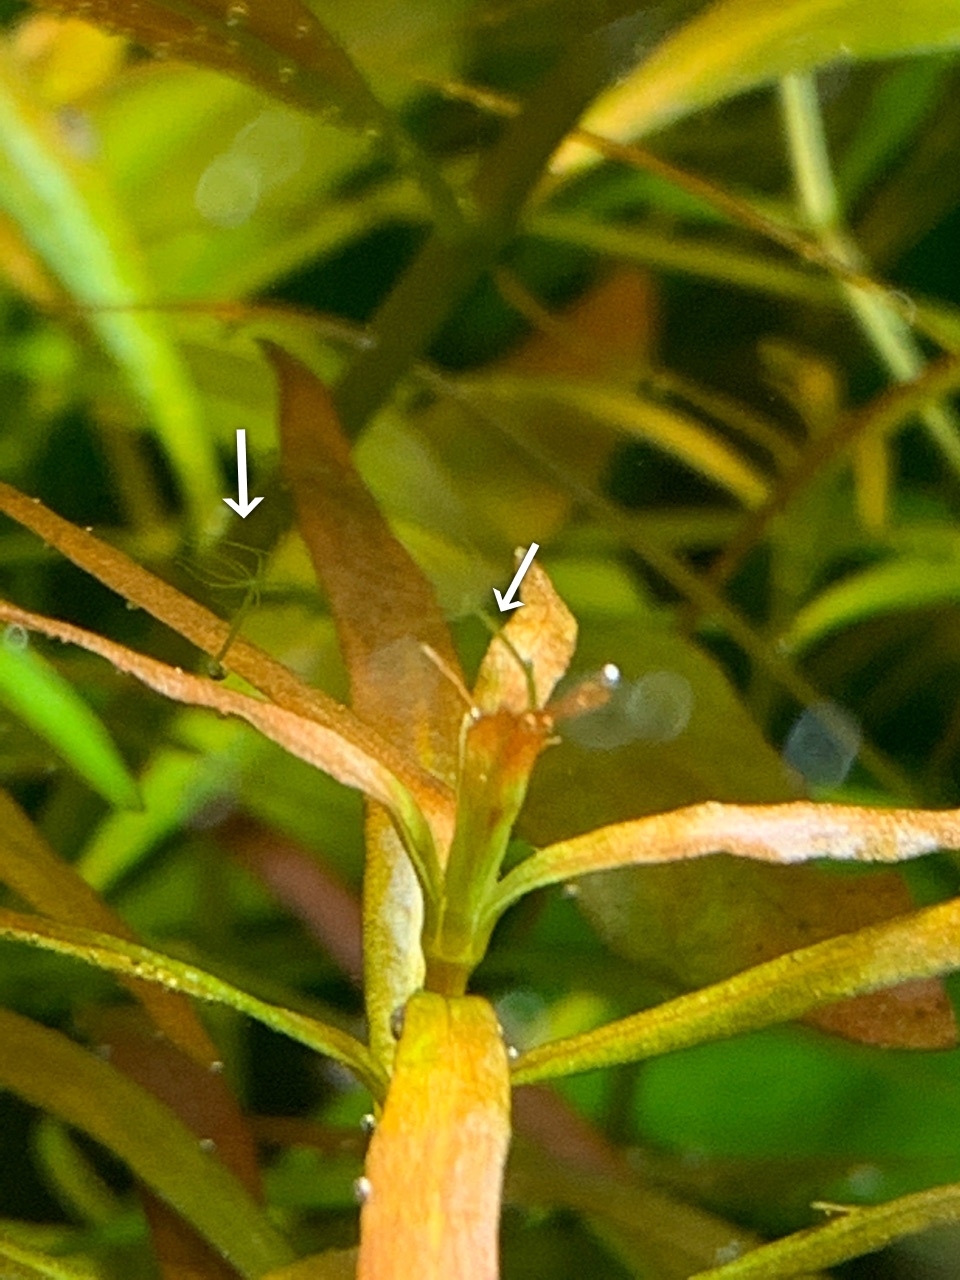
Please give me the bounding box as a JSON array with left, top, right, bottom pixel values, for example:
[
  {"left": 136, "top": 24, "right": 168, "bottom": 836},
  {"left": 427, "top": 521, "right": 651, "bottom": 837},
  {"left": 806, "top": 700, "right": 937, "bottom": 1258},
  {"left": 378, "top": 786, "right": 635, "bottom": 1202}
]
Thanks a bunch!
[{"left": 0, "top": 909, "right": 384, "bottom": 1097}]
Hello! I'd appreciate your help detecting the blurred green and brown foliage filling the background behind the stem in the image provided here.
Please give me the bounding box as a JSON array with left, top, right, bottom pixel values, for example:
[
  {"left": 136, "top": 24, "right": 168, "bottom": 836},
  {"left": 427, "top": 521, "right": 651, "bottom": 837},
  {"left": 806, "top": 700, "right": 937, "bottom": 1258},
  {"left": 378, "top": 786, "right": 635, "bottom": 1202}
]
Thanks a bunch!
[{"left": 0, "top": 0, "right": 960, "bottom": 1280}]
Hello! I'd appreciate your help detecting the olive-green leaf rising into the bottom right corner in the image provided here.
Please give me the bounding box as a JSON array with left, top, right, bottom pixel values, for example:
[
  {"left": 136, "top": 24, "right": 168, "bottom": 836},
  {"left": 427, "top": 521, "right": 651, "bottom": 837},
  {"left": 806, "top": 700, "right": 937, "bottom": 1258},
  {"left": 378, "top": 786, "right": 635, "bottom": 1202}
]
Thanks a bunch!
[{"left": 690, "top": 1184, "right": 960, "bottom": 1280}]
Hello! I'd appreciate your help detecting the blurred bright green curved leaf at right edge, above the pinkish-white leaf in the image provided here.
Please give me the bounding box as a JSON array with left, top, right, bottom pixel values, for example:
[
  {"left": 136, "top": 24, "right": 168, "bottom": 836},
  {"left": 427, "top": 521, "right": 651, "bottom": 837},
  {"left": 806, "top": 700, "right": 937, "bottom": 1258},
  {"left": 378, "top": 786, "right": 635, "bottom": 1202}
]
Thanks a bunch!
[{"left": 781, "top": 557, "right": 960, "bottom": 653}]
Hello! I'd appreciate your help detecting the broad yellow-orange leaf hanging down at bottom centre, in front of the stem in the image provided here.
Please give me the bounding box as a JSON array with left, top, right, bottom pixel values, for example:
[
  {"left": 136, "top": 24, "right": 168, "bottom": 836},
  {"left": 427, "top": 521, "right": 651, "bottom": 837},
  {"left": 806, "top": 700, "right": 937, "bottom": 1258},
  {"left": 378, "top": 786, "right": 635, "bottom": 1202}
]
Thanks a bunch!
[{"left": 357, "top": 992, "right": 509, "bottom": 1280}]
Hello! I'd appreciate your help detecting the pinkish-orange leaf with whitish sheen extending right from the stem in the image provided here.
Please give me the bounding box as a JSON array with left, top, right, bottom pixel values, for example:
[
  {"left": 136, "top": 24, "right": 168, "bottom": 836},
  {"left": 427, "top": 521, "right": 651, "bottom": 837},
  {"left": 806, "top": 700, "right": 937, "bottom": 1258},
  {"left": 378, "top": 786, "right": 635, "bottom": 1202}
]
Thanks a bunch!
[{"left": 494, "top": 800, "right": 960, "bottom": 914}]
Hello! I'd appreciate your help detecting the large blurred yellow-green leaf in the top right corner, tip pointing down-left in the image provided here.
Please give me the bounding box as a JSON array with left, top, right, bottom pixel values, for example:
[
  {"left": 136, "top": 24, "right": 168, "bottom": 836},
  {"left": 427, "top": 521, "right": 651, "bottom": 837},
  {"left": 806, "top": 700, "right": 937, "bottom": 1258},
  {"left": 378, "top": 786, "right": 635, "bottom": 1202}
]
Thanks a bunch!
[{"left": 554, "top": 0, "right": 960, "bottom": 169}]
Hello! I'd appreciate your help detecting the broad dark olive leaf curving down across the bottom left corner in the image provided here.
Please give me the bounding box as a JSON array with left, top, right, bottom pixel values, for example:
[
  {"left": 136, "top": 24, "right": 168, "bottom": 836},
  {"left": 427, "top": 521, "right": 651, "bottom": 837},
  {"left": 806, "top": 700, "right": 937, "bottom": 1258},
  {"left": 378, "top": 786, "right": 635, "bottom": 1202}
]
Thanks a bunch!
[{"left": 0, "top": 1010, "right": 291, "bottom": 1280}]
